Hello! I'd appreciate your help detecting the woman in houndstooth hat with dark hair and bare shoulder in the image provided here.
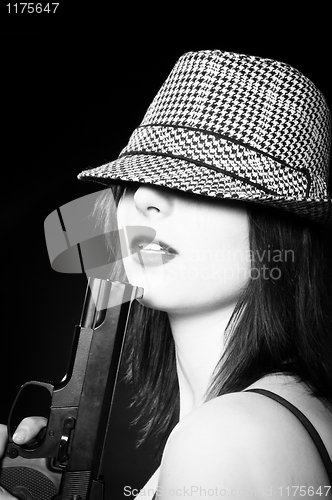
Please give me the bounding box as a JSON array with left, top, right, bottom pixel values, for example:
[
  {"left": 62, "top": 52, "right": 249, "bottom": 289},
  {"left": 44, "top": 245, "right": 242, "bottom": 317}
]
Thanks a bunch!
[{"left": 0, "top": 51, "right": 332, "bottom": 499}]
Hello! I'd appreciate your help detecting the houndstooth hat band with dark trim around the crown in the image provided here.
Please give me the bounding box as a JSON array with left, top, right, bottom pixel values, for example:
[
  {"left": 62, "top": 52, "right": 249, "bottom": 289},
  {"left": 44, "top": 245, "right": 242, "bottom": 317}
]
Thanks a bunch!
[{"left": 119, "top": 125, "right": 310, "bottom": 199}]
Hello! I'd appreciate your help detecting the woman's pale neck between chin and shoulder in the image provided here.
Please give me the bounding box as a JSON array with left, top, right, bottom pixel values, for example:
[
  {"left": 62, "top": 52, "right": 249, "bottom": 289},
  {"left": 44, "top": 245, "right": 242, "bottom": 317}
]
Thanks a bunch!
[{"left": 169, "top": 305, "right": 234, "bottom": 419}]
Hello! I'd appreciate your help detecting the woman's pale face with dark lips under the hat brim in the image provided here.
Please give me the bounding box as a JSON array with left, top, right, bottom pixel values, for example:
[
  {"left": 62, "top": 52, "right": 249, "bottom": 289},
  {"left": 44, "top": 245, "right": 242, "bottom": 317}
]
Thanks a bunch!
[{"left": 118, "top": 185, "right": 250, "bottom": 314}]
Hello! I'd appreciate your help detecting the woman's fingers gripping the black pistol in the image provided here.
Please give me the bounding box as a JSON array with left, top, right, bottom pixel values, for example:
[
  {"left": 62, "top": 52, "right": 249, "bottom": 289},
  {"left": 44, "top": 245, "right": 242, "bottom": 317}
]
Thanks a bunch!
[{"left": 0, "top": 417, "right": 47, "bottom": 500}]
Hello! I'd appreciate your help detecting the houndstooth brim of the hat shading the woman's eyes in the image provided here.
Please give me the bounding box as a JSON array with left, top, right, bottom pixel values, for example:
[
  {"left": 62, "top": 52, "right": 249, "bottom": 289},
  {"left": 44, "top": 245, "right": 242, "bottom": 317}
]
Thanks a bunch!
[{"left": 78, "top": 154, "right": 332, "bottom": 225}]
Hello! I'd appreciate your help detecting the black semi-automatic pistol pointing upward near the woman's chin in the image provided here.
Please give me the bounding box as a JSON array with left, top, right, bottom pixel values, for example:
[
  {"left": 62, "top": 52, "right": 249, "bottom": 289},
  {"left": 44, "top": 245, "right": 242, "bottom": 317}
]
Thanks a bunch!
[{"left": 0, "top": 278, "right": 143, "bottom": 500}]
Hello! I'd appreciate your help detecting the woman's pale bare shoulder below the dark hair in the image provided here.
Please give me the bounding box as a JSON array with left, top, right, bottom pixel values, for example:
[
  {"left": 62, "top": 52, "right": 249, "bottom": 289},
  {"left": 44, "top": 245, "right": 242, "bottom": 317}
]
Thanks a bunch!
[{"left": 160, "top": 393, "right": 328, "bottom": 498}]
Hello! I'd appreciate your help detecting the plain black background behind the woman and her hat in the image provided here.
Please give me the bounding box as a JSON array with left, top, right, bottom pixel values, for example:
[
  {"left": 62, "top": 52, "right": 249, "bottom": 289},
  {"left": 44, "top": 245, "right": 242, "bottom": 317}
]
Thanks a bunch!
[{"left": 0, "top": 6, "right": 331, "bottom": 500}]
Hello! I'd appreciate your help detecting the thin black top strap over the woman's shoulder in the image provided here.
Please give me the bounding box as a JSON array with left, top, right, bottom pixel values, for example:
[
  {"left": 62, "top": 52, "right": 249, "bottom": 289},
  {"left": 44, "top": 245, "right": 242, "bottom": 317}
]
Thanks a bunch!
[{"left": 243, "top": 389, "right": 332, "bottom": 485}]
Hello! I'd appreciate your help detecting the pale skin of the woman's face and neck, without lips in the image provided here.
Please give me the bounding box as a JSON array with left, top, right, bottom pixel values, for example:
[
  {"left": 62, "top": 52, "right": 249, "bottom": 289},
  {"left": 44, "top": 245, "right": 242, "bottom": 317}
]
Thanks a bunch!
[{"left": 118, "top": 186, "right": 250, "bottom": 418}]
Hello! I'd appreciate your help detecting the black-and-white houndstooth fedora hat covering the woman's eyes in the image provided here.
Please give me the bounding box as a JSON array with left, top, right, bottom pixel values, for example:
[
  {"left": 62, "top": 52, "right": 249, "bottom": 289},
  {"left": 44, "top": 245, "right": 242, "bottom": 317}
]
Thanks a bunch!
[{"left": 79, "top": 50, "right": 332, "bottom": 223}]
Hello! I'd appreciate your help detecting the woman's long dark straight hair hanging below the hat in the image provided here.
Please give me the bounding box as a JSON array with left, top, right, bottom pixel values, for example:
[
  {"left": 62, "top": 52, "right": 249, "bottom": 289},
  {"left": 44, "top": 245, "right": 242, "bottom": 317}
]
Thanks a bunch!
[{"left": 92, "top": 186, "right": 332, "bottom": 456}]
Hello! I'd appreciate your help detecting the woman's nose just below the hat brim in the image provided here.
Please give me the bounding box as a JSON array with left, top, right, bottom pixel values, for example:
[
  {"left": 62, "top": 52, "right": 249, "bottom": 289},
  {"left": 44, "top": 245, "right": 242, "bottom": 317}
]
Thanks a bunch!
[{"left": 134, "top": 186, "right": 173, "bottom": 218}]
